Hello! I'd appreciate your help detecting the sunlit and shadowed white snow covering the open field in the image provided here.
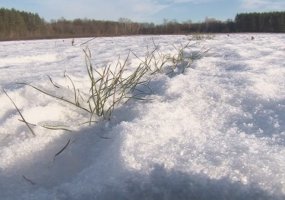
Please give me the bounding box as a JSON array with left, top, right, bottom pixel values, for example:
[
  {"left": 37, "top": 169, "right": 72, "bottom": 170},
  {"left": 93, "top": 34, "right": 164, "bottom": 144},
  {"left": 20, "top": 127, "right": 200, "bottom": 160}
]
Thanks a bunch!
[{"left": 0, "top": 34, "right": 285, "bottom": 200}]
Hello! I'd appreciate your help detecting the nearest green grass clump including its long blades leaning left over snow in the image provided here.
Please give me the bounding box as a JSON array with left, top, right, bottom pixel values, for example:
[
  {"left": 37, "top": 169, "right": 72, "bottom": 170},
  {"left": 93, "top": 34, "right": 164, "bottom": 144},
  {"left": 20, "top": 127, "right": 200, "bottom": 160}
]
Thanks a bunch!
[{"left": 18, "top": 48, "right": 149, "bottom": 126}]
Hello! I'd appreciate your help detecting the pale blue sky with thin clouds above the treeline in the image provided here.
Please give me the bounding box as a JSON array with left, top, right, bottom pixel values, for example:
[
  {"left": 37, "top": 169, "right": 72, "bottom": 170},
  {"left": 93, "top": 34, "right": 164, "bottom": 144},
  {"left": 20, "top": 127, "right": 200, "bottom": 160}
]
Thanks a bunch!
[{"left": 0, "top": 0, "right": 285, "bottom": 23}]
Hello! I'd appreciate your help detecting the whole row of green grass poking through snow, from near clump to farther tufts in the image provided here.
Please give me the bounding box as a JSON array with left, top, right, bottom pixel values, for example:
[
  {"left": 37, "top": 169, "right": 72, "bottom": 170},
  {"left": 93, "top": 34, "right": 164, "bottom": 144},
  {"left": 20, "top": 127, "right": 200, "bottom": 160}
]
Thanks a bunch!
[{"left": 11, "top": 37, "right": 206, "bottom": 134}]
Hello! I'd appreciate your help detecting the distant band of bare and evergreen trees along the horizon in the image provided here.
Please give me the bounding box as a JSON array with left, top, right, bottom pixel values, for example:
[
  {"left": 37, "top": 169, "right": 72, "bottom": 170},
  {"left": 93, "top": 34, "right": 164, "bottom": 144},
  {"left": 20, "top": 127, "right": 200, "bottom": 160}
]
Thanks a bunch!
[{"left": 0, "top": 8, "right": 285, "bottom": 40}]
